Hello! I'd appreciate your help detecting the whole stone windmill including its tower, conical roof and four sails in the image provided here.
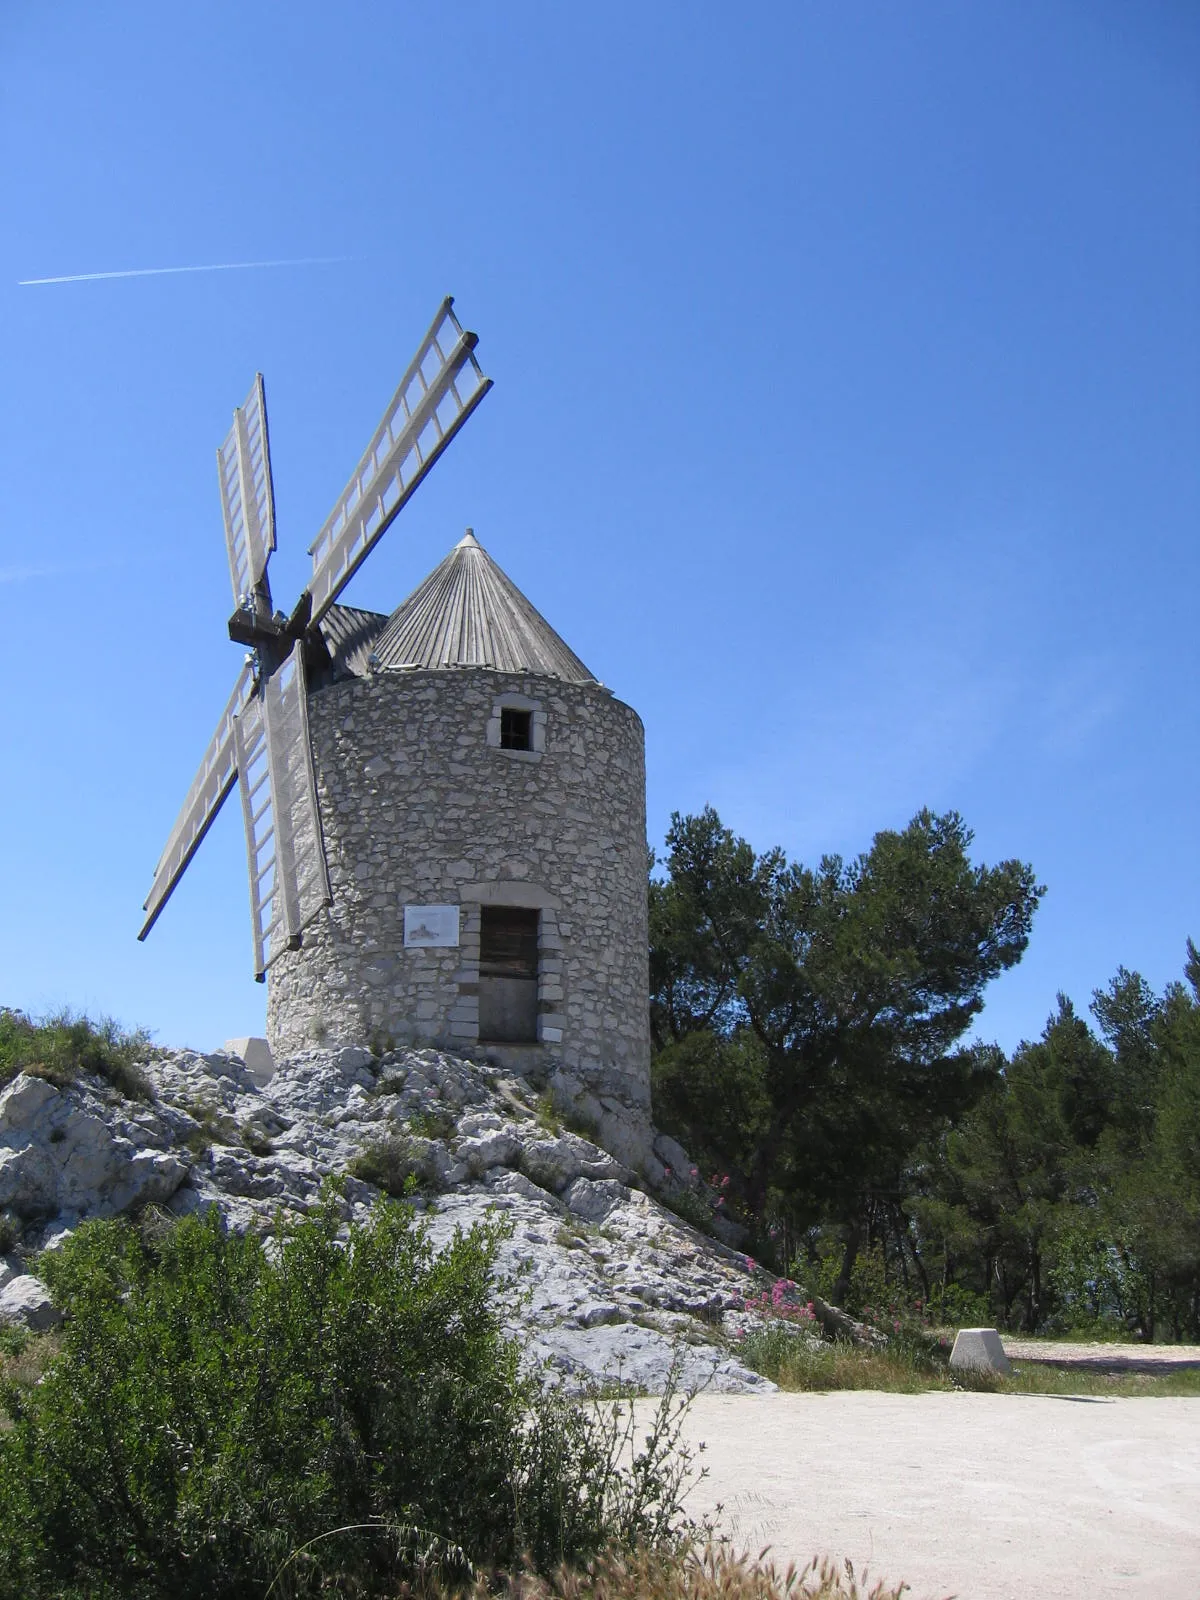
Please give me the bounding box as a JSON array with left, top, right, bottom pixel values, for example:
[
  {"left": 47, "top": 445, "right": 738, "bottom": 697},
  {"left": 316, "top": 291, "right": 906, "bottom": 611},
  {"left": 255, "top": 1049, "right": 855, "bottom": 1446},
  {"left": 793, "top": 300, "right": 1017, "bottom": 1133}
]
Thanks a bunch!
[{"left": 139, "top": 298, "right": 650, "bottom": 1154}]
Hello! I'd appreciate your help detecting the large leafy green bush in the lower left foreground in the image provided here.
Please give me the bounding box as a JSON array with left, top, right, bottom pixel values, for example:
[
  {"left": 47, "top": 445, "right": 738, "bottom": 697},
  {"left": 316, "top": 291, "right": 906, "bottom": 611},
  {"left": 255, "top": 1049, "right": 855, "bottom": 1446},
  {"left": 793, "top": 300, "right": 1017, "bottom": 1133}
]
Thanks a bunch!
[{"left": 0, "top": 1195, "right": 694, "bottom": 1600}]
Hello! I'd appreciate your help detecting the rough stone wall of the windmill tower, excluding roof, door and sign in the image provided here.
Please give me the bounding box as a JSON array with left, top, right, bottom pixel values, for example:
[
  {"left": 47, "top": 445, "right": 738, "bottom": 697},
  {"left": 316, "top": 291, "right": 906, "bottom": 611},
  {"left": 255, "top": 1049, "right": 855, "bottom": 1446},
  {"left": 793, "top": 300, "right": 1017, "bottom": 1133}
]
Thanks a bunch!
[{"left": 267, "top": 667, "right": 650, "bottom": 1120}]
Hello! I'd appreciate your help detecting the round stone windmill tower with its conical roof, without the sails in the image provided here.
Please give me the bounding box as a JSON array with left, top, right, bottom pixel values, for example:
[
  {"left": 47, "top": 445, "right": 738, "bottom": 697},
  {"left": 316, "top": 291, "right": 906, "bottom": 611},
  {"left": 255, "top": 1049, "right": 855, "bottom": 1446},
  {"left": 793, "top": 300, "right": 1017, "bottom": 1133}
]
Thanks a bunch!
[{"left": 267, "top": 533, "right": 650, "bottom": 1154}]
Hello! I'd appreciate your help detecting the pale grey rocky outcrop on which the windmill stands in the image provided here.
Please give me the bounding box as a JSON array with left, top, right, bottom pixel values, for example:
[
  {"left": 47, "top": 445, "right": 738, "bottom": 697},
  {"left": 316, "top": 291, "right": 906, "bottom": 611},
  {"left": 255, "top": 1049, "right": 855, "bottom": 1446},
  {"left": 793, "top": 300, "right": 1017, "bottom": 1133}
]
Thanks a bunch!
[{"left": 0, "top": 1048, "right": 793, "bottom": 1392}]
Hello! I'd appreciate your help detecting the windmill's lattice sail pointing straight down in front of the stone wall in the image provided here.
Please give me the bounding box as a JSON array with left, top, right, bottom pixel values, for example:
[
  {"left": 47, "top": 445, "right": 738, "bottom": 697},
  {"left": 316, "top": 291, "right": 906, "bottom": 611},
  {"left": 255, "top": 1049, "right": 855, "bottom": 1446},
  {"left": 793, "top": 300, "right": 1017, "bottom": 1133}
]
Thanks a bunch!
[{"left": 234, "top": 650, "right": 330, "bottom": 982}]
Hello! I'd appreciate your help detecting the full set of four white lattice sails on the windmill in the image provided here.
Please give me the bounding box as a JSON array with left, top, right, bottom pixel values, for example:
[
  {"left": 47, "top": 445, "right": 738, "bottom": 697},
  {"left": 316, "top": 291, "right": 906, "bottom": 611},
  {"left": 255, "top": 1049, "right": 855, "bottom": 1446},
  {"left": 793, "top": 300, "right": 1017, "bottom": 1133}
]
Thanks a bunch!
[{"left": 138, "top": 296, "right": 491, "bottom": 982}]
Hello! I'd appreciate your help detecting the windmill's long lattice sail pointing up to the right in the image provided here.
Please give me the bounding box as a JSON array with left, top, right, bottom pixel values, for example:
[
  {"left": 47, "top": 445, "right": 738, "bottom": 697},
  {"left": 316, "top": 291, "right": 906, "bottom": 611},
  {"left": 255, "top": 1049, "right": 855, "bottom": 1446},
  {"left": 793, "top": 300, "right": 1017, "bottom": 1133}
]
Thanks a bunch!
[{"left": 309, "top": 294, "right": 491, "bottom": 622}]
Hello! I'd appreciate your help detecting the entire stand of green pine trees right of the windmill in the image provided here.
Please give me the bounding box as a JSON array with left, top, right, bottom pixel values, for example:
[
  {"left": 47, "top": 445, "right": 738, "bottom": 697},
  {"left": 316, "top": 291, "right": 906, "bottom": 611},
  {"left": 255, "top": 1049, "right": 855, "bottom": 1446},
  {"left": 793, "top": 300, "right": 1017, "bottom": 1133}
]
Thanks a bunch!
[{"left": 650, "top": 810, "right": 1200, "bottom": 1339}]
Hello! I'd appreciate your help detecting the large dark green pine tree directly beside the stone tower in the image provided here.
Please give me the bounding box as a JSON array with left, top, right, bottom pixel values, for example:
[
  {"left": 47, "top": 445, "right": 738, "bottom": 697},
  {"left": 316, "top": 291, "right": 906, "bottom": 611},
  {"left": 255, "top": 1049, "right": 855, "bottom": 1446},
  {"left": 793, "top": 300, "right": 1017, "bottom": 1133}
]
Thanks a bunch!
[{"left": 650, "top": 808, "right": 1043, "bottom": 1278}]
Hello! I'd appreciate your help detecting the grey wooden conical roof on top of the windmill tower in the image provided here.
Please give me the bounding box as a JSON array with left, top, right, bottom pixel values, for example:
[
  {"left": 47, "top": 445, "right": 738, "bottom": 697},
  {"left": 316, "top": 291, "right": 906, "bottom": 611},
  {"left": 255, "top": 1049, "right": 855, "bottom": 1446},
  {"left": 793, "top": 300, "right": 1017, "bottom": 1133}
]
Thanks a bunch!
[{"left": 373, "top": 528, "right": 595, "bottom": 683}]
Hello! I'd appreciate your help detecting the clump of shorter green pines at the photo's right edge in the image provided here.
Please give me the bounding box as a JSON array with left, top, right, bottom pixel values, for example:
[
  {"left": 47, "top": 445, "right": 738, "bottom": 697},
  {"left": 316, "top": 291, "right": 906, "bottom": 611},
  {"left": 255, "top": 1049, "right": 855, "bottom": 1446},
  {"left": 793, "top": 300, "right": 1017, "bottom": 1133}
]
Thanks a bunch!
[{"left": 912, "top": 941, "right": 1200, "bottom": 1339}]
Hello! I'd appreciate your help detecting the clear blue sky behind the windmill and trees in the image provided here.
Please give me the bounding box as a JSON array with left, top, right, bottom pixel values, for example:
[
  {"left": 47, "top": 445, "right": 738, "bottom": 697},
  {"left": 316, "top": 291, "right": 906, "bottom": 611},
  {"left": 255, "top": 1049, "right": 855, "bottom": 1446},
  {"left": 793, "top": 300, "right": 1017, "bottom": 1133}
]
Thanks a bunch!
[{"left": 0, "top": 0, "right": 1200, "bottom": 1048}]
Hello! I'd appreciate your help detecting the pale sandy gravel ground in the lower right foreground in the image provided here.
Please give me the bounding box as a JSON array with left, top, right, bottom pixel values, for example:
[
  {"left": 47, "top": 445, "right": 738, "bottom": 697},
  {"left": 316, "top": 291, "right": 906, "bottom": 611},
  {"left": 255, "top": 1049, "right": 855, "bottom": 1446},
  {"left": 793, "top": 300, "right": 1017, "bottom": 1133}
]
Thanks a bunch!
[{"left": 668, "top": 1392, "right": 1200, "bottom": 1600}]
